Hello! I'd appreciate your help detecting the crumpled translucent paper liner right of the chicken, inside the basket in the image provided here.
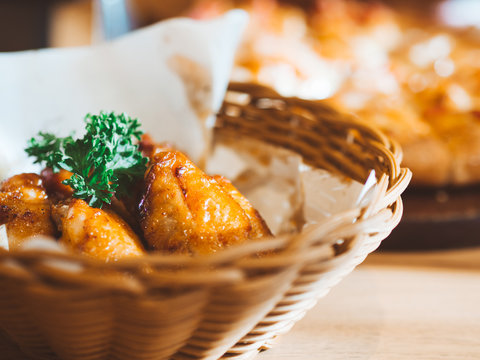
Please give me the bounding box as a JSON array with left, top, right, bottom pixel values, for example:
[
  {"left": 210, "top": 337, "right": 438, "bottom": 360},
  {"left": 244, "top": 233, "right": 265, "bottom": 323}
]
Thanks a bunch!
[{"left": 207, "top": 138, "right": 377, "bottom": 235}]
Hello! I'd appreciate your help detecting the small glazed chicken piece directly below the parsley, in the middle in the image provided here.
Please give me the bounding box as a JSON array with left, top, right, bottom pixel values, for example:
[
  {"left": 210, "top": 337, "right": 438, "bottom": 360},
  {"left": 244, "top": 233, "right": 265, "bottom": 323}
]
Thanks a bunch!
[{"left": 52, "top": 199, "right": 145, "bottom": 262}]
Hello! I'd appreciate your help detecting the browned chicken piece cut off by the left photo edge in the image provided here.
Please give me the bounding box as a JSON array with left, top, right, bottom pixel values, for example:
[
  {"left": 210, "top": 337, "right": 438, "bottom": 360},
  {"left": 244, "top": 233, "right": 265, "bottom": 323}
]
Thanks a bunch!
[{"left": 0, "top": 173, "right": 57, "bottom": 249}]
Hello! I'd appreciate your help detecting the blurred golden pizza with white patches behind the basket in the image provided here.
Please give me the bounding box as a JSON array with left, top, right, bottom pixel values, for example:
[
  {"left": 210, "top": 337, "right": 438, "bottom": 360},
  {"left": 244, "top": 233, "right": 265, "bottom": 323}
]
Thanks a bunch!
[{"left": 192, "top": 0, "right": 480, "bottom": 186}]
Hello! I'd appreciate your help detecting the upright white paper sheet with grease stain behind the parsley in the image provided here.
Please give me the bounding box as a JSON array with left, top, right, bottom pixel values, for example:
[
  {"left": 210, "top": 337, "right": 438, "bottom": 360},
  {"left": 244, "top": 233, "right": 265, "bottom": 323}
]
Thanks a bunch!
[{"left": 0, "top": 10, "right": 247, "bottom": 179}]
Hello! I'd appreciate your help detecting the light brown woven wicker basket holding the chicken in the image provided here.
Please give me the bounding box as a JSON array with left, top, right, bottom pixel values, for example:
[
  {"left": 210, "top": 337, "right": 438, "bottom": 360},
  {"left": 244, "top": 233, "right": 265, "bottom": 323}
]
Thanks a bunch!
[{"left": 0, "top": 84, "right": 410, "bottom": 360}]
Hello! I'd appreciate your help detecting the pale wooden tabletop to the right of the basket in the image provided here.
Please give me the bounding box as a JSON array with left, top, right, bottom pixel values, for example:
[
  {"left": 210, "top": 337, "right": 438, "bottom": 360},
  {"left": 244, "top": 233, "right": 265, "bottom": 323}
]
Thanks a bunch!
[{"left": 257, "top": 248, "right": 480, "bottom": 360}]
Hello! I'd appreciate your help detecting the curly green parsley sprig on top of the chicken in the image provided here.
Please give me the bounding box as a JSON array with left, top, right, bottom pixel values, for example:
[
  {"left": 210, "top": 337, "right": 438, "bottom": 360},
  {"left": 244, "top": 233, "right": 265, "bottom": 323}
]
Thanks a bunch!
[{"left": 25, "top": 112, "right": 148, "bottom": 207}]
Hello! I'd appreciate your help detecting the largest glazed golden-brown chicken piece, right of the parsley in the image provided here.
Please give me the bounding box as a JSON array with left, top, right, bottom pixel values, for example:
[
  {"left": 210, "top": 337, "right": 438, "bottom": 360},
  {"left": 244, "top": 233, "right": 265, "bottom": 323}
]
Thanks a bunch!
[{"left": 139, "top": 150, "right": 270, "bottom": 254}]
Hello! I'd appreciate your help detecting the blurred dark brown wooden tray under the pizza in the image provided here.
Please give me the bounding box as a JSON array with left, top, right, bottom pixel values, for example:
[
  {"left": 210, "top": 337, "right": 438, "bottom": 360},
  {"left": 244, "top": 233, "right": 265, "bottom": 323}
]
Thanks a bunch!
[{"left": 380, "top": 186, "right": 480, "bottom": 251}]
